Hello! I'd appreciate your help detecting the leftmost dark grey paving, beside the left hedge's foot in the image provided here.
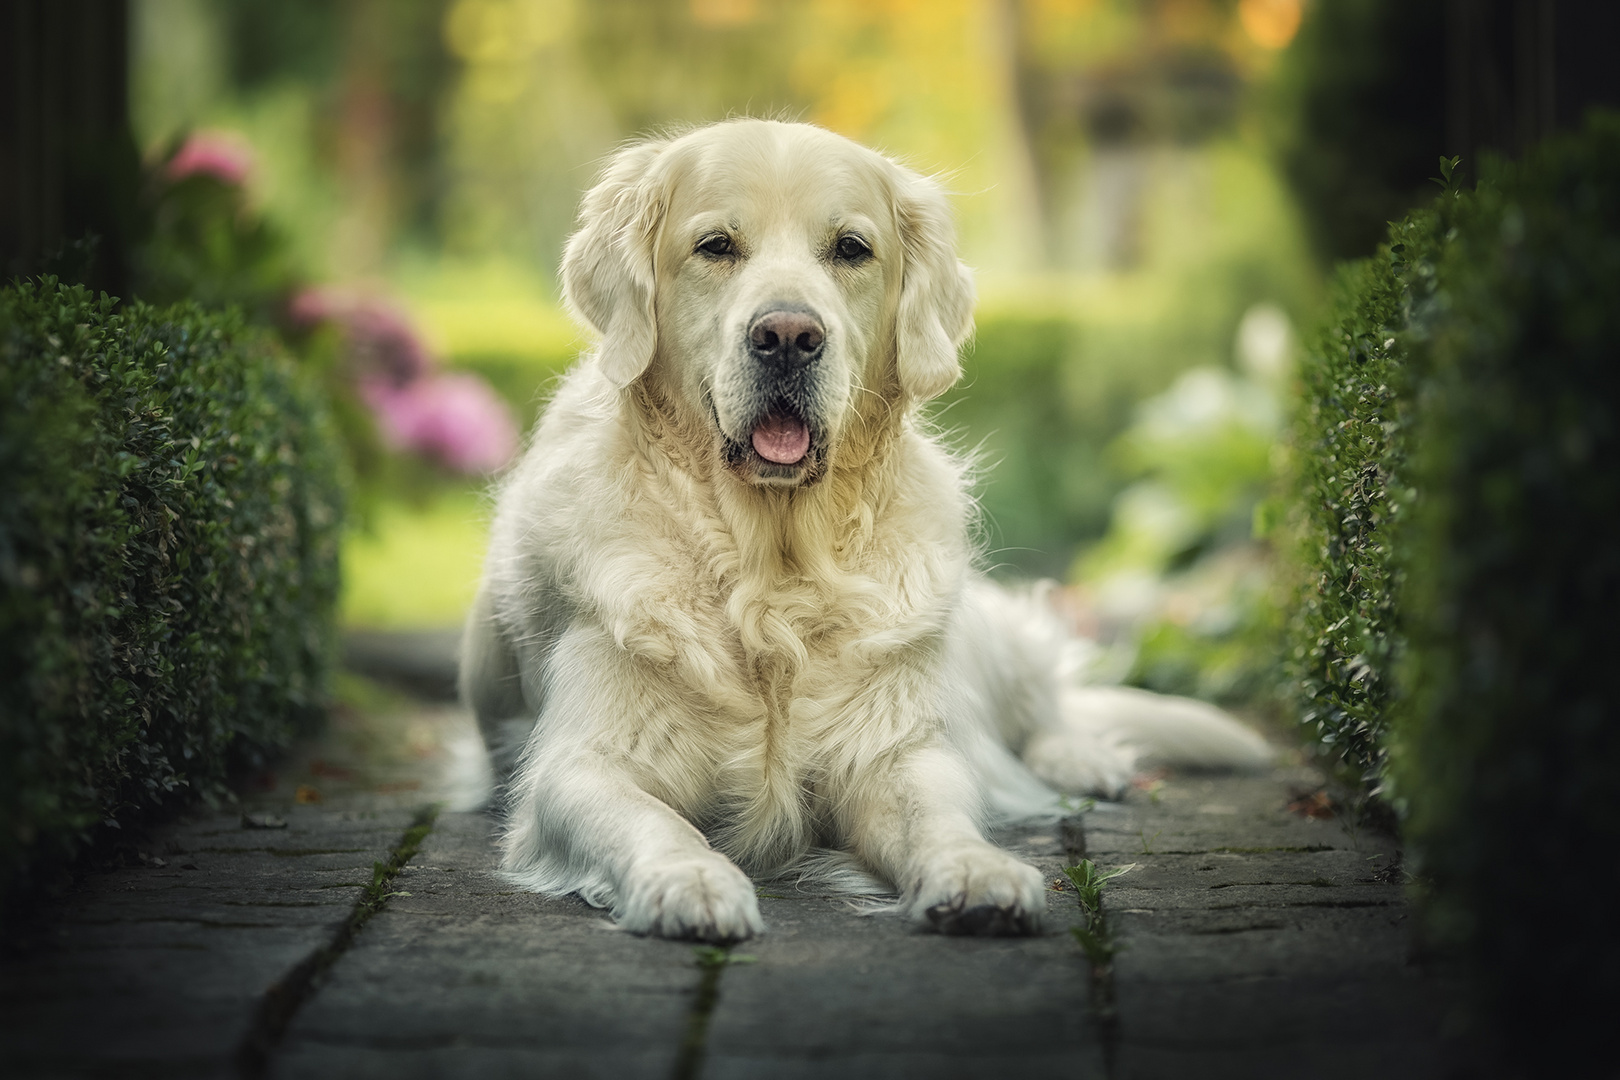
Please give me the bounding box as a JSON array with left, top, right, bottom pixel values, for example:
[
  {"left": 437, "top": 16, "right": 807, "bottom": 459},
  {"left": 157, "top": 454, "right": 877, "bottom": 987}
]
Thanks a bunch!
[{"left": 0, "top": 806, "right": 410, "bottom": 1077}]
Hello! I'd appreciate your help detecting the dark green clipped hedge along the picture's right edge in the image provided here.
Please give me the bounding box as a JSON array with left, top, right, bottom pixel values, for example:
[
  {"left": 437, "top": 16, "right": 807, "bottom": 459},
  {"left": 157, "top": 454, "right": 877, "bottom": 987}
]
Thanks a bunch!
[{"left": 1293, "top": 115, "right": 1620, "bottom": 1075}]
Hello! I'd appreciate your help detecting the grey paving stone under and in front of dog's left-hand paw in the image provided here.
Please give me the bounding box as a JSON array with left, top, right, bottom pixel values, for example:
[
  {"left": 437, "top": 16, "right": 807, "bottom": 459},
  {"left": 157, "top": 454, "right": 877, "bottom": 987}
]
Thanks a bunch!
[{"left": 272, "top": 813, "right": 701, "bottom": 1078}]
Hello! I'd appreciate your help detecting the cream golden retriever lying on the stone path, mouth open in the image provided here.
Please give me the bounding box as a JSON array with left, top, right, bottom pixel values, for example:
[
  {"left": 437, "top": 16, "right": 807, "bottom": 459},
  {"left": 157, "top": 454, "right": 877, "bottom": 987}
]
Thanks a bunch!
[{"left": 462, "top": 120, "right": 1267, "bottom": 941}]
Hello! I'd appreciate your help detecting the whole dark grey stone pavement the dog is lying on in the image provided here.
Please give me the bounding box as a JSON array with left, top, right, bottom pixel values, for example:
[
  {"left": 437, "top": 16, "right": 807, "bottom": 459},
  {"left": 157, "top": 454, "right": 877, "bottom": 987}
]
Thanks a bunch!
[{"left": 0, "top": 680, "right": 1470, "bottom": 1080}]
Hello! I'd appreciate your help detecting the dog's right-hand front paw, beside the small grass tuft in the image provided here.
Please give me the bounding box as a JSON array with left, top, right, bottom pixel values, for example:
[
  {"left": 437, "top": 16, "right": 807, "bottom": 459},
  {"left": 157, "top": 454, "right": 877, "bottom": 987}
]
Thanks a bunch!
[{"left": 906, "top": 844, "right": 1047, "bottom": 936}]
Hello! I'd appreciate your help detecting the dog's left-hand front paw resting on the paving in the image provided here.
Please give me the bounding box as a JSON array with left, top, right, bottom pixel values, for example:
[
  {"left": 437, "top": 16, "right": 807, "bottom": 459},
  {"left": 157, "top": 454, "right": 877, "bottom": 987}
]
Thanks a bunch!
[{"left": 619, "top": 853, "right": 765, "bottom": 944}]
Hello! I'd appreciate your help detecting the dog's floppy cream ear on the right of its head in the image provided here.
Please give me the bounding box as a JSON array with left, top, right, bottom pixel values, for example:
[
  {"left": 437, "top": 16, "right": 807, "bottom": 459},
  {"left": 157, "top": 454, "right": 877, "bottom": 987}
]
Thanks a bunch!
[{"left": 894, "top": 168, "right": 974, "bottom": 402}]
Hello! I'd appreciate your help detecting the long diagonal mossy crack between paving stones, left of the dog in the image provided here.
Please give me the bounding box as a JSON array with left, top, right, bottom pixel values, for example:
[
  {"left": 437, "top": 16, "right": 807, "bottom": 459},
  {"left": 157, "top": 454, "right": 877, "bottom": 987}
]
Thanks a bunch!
[{"left": 237, "top": 805, "right": 439, "bottom": 1080}]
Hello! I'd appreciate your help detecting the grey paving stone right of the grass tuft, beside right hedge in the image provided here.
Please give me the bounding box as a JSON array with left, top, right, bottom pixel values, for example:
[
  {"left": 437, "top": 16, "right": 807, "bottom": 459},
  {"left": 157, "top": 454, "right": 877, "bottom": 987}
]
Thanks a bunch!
[{"left": 1085, "top": 769, "right": 1470, "bottom": 1080}]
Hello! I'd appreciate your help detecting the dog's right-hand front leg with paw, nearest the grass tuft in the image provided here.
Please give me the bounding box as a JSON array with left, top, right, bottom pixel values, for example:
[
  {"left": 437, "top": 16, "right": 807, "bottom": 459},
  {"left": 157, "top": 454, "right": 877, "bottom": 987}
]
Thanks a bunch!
[{"left": 846, "top": 746, "right": 1047, "bottom": 934}]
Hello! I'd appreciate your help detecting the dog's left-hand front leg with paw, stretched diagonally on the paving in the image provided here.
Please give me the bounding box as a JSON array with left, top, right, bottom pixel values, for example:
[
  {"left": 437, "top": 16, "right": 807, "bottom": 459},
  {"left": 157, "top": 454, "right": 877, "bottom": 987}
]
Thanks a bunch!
[{"left": 502, "top": 746, "right": 765, "bottom": 942}]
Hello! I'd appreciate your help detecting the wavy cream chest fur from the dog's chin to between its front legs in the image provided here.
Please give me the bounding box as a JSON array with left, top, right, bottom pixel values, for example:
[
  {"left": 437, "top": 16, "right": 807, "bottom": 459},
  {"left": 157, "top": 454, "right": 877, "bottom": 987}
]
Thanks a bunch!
[{"left": 508, "top": 393, "right": 967, "bottom": 870}]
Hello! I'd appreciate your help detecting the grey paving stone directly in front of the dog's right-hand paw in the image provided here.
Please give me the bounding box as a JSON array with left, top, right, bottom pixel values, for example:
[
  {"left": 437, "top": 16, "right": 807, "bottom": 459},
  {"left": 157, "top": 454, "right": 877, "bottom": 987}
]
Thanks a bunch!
[{"left": 703, "top": 826, "right": 1103, "bottom": 1080}]
